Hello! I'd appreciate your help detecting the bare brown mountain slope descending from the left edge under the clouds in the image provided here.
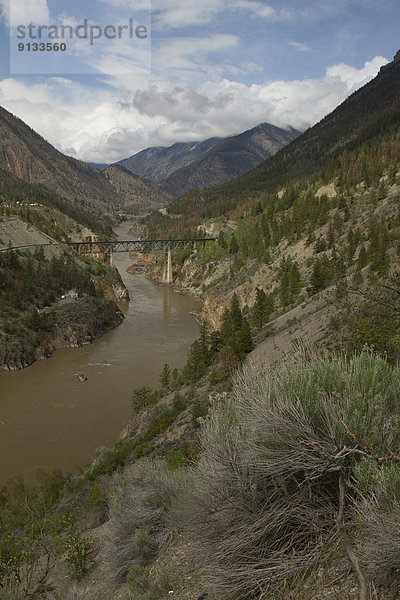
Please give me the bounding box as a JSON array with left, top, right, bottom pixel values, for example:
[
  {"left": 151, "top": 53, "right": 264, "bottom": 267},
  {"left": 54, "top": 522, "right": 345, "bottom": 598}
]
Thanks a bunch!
[{"left": 0, "top": 107, "right": 170, "bottom": 216}]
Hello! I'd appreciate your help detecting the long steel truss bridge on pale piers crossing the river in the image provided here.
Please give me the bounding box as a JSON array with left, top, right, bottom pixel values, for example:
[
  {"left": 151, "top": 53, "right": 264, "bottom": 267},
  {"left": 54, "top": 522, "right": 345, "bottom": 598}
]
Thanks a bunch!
[{"left": 0, "top": 238, "right": 216, "bottom": 283}]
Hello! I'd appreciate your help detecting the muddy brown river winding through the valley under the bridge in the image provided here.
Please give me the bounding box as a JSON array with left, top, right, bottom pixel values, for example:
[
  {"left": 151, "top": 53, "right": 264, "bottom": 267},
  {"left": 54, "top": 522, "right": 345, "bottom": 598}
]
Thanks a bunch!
[{"left": 0, "top": 223, "right": 201, "bottom": 483}]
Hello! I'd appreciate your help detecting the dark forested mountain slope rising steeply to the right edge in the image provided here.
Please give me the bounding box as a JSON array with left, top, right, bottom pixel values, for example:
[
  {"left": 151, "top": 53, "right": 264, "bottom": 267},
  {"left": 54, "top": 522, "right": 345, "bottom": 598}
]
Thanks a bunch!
[{"left": 148, "top": 49, "right": 400, "bottom": 234}]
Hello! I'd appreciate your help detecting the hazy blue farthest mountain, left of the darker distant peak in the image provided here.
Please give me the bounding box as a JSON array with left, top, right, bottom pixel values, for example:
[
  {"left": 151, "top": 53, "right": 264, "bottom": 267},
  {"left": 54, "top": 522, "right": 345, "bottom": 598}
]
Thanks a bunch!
[{"left": 117, "top": 137, "right": 222, "bottom": 183}]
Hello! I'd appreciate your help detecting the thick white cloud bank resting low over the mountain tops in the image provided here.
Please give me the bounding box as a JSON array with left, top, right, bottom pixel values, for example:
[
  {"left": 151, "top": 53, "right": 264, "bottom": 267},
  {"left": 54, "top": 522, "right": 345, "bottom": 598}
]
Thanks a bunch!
[{"left": 0, "top": 56, "right": 387, "bottom": 162}]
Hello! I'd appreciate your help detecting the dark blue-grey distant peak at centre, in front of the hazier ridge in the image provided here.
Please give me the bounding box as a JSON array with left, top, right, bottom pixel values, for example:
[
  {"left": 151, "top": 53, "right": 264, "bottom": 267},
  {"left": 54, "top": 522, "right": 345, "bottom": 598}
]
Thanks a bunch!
[{"left": 162, "top": 123, "right": 300, "bottom": 196}]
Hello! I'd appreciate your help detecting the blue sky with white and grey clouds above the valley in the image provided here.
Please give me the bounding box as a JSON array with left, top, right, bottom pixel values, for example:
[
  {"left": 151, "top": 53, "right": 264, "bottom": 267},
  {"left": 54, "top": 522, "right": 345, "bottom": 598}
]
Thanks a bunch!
[{"left": 0, "top": 0, "right": 400, "bottom": 163}]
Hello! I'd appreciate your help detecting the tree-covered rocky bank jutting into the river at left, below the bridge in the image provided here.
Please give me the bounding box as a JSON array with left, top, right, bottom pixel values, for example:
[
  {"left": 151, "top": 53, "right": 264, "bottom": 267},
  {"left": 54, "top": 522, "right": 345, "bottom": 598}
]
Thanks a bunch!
[{"left": 0, "top": 246, "right": 129, "bottom": 371}]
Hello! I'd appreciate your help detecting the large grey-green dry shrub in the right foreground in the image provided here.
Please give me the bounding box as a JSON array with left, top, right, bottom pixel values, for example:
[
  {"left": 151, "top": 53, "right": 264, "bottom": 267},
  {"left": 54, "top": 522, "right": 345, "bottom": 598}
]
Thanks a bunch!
[{"left": 175, "top": 355, "right": 400, "bottom": 599}]
